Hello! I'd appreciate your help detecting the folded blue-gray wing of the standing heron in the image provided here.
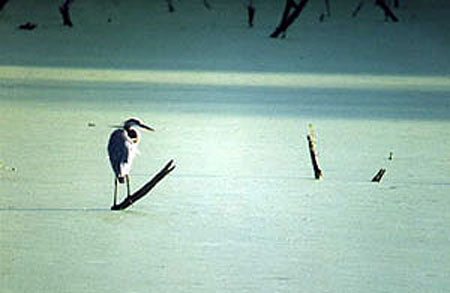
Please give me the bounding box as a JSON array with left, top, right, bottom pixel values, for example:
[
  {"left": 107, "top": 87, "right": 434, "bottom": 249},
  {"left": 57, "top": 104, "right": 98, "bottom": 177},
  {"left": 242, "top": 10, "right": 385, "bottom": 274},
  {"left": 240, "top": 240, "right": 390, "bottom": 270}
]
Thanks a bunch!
[{"left": 108, "top": 129, "right": 130, "bottom": 177}]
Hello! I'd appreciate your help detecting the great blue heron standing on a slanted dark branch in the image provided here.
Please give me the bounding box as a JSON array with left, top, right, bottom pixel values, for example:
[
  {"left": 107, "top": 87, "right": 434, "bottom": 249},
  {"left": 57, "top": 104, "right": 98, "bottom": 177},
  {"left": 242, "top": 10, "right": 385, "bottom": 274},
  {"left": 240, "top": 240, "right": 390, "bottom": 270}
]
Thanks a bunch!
[{"left": 108, "top": 118, "right": 154, "bottom": 205}]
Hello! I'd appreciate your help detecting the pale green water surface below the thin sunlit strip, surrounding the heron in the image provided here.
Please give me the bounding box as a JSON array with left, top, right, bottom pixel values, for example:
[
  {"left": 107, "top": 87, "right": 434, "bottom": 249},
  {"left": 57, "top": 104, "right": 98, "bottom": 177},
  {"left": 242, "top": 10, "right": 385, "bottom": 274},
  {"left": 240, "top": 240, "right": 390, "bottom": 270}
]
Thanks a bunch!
[{"left": 0, "top": 80, "right": 450, "bottom": 292}]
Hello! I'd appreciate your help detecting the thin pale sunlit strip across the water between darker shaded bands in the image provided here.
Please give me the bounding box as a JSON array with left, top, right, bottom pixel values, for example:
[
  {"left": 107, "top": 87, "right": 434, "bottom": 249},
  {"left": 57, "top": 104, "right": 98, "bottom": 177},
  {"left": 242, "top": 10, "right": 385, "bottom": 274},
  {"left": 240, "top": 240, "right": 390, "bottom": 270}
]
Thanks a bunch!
[{"left": 0, "top": 66, "right": 450, "bottom": 91}]
